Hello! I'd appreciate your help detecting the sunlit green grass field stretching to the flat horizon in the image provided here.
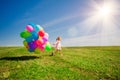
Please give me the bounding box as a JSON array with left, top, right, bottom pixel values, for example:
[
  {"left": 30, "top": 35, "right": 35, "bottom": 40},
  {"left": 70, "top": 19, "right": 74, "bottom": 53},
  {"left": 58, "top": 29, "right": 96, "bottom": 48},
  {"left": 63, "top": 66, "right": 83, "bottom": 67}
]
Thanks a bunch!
[{"left": 0, "top": 47, "right": 120, "bottom": 80}]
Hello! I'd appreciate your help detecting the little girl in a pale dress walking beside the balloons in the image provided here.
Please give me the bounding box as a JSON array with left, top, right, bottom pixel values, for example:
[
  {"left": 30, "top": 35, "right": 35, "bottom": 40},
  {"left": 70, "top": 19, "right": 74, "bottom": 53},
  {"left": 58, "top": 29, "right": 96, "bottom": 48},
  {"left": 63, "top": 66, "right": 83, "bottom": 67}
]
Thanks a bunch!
[{"left": 52, "top": 36, "right": 63, "bottom": 56}]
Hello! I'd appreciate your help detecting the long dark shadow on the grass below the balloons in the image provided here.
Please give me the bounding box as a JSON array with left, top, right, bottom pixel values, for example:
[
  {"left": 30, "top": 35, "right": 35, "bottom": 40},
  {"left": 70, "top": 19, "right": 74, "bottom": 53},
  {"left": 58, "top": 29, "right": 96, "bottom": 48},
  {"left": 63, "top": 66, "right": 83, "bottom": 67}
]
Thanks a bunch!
[{"left": 0, "top": 56, "right": 40, "bottom": 61}]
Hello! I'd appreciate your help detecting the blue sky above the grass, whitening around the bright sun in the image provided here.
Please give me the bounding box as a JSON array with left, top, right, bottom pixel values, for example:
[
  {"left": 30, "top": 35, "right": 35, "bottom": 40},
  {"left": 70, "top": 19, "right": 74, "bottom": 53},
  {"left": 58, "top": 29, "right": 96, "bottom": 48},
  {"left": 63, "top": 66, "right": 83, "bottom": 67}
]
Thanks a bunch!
[{"left": 0, "top": 0, "right": 120, "bottom": 46}]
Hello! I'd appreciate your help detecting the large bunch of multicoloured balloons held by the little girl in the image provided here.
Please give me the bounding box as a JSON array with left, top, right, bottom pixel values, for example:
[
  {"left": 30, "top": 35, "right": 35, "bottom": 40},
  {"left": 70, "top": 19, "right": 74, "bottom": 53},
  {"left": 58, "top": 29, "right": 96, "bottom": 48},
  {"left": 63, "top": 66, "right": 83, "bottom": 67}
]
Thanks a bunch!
[{"left": 20, "top": 23, "right": 51, "bottom": 52}]
